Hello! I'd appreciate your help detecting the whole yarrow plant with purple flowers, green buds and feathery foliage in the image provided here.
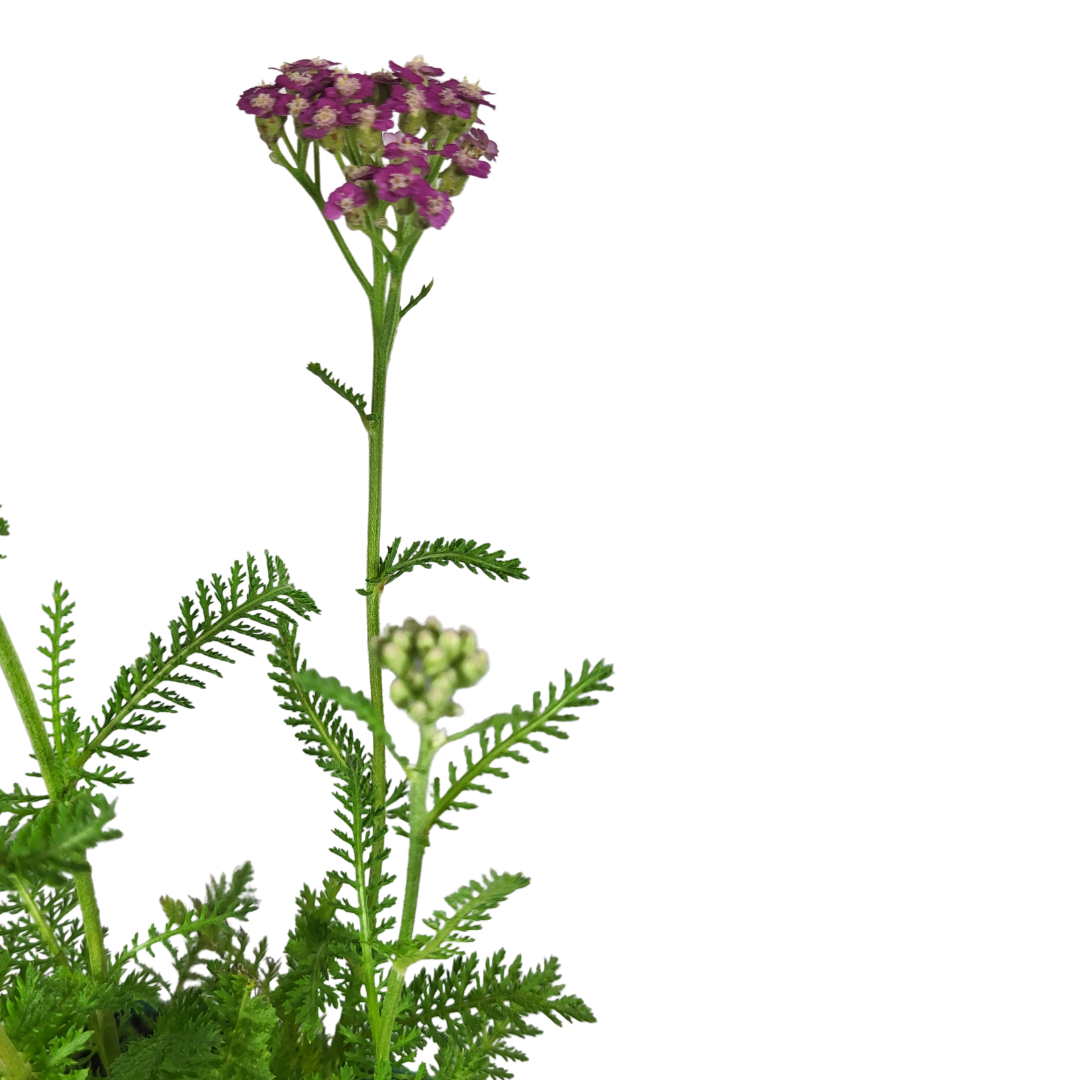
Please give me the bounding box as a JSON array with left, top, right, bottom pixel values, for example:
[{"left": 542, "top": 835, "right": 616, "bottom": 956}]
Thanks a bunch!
[{"left": 0, "top": 56, "right": 611, "bottom": 1080}]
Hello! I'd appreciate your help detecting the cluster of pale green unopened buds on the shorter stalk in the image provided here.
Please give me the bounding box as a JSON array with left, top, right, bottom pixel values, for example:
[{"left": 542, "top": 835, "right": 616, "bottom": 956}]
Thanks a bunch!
[{"left": 372, "top": 618, "right": 488, "bottom": 724}]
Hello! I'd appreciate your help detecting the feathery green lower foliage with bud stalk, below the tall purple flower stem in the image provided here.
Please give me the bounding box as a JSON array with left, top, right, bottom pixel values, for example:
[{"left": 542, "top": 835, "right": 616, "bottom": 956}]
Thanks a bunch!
[{"left": 0, "top": 556, "right": 611, "bottom": 1080}]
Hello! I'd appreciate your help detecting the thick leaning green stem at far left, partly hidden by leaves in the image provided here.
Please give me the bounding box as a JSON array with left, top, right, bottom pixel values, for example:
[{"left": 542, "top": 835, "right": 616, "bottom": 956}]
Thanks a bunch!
[{"left": 0, "top": 619, "right": 120, "bottom": 1068}]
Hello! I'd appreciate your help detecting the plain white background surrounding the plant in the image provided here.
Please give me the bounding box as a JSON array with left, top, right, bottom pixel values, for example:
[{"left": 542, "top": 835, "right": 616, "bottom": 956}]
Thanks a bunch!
[{"left": 0, "top": 0, "right": 1080, "bottom": 1080}]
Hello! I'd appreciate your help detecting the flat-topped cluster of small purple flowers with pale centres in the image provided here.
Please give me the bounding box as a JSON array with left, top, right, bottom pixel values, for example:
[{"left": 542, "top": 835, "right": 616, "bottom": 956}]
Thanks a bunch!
[{"left": 237, "top": 56, "right": 499, "bottom": 231}]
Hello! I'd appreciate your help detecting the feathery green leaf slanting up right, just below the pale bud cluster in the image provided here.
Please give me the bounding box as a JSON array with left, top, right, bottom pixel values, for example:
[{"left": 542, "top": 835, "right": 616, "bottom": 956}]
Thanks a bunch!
[{"left": 424, "top": 660, "right": 613, "bottom": 834}]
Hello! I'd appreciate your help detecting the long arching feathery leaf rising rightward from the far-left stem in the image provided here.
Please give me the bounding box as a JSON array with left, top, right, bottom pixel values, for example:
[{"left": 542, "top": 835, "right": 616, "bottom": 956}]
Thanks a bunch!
[{"left": 68, "top": 552, "right": 319, "bottom": 786}]
